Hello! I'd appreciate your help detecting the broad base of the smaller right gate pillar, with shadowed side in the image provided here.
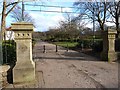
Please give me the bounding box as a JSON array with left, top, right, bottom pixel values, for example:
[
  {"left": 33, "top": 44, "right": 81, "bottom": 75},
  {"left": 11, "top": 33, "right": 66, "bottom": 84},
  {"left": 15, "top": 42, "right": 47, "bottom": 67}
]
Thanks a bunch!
[{"left": 101, "top": 52, "right": 117, "bottom": 62}]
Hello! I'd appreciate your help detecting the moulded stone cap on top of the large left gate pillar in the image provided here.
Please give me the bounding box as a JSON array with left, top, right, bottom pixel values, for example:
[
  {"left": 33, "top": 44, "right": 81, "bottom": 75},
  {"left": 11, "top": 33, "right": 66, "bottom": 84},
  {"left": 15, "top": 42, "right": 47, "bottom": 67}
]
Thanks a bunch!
[{"left": 11, "top": 22, "right": 33, "bottom": 31}]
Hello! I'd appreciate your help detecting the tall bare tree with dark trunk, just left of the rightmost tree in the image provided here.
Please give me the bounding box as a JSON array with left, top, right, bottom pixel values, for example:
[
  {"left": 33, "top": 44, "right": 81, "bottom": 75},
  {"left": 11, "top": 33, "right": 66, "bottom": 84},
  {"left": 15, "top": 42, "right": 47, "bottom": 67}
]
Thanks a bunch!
[{"left": 74, "top": 1, "right": 109, "bottom": 31}]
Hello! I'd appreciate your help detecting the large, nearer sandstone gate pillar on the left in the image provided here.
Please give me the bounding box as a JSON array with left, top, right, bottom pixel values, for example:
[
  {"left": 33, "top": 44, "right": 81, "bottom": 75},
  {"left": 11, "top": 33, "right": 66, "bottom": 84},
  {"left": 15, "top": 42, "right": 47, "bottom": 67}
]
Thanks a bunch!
[{"left": 12, "top": 22, "right": 35, "bottom": 83}]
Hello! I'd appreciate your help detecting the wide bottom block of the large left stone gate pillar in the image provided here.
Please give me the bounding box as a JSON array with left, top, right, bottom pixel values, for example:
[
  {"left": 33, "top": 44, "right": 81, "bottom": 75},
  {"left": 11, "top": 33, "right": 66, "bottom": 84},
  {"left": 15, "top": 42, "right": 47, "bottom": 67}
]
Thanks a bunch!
[{"left": 13, "top": 63, "right": 35, "bottom": 84}]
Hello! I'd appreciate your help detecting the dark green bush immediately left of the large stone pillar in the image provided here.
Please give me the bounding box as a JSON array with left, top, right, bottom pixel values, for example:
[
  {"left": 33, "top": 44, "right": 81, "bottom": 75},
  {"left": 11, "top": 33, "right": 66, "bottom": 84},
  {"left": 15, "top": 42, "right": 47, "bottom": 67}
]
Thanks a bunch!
[{"left": 2, "top": 40, "right": 16, "bottom": 65}]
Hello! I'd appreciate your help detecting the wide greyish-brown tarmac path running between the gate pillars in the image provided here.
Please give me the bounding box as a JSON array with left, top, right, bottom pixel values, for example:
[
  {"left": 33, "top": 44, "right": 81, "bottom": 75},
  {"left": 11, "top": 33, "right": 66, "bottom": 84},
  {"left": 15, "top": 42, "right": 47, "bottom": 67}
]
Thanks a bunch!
[{"left": 6, "top": 41, "right": 118, "bottom": 88}]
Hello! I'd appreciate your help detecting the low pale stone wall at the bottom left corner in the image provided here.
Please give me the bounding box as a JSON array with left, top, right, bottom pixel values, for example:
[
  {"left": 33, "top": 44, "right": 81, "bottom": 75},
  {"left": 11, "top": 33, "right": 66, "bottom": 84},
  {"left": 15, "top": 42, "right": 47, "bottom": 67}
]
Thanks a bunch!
[{"left": 0, "top": 65, "right": 10, "bottom": 89}]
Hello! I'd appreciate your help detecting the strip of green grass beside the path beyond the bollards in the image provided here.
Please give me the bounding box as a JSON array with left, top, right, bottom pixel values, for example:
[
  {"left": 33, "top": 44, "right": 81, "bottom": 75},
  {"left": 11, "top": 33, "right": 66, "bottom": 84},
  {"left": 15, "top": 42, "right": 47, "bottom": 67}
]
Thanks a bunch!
[{"left": 53, "top": 42, "right": 78, "bottom": 48}]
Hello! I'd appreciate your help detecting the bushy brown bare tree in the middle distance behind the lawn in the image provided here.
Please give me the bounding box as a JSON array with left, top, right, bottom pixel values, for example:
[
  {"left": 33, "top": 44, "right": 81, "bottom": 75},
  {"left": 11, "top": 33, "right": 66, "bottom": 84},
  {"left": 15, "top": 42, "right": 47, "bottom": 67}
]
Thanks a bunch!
[{"left": 56, "top": 13, "right": 85, "bottom": 40}]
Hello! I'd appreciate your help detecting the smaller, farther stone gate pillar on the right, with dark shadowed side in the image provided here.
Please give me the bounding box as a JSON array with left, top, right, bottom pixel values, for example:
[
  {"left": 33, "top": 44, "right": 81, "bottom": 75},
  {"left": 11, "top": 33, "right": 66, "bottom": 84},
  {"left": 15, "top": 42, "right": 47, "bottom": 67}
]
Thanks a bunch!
[{"left": 101, "top": 29, "right": 117, "bottom": 62}]
